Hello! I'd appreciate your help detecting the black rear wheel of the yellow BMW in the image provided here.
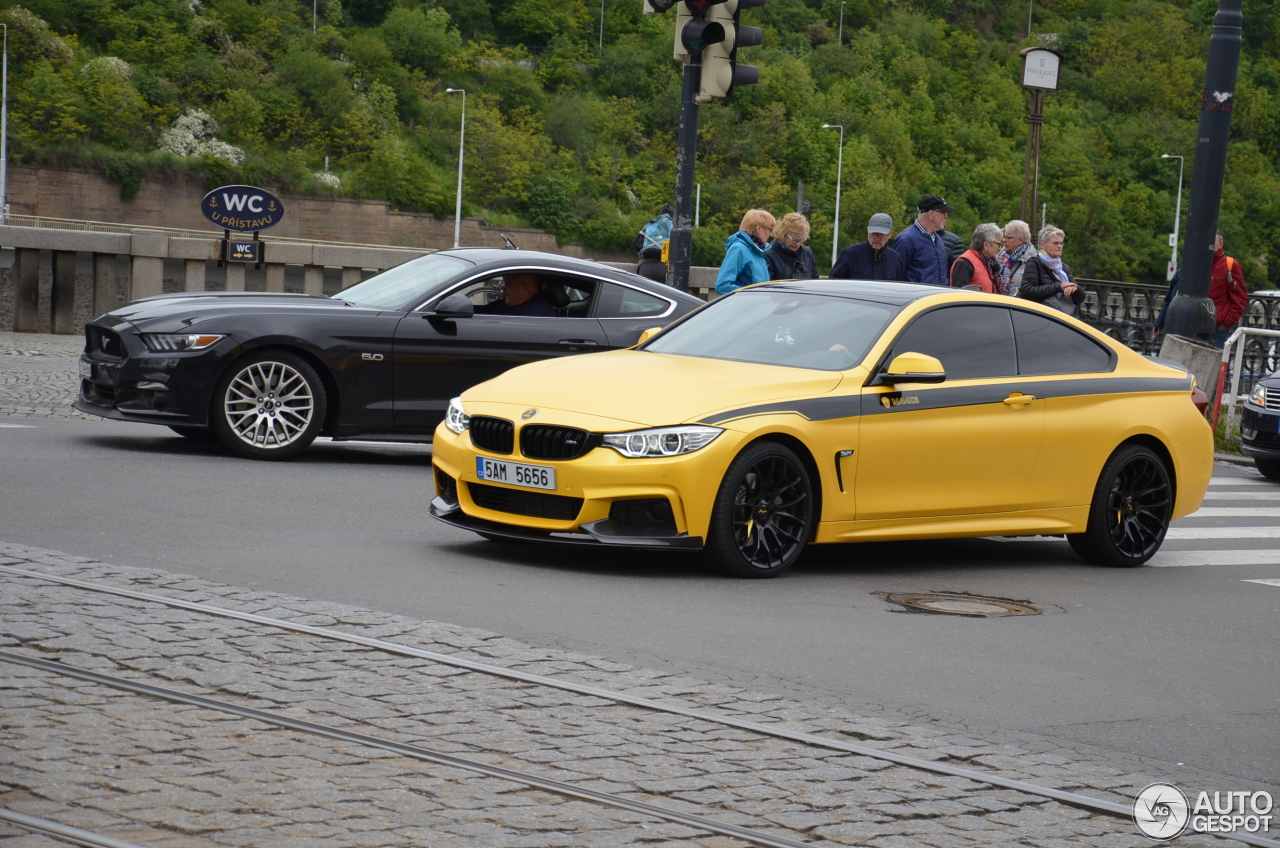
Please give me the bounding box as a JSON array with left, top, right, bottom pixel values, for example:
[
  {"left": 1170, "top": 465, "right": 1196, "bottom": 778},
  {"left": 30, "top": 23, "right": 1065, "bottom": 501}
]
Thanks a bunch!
[{"left": 1066, "top": 444, "right": 1174, "bottom": 567}]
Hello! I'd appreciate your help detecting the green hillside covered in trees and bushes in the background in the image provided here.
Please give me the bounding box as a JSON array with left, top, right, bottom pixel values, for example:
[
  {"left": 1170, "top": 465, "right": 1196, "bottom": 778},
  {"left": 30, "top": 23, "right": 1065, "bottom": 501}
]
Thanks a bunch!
[{"left": 0, "top": 0, "right": 1280, "bottom": 287}]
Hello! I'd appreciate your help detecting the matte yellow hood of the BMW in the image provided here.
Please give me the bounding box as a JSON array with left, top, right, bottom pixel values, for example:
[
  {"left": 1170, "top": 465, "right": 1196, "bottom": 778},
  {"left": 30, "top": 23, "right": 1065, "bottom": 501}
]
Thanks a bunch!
[{"left": 462, "top": 350, "right": 842, "bottom": 427}]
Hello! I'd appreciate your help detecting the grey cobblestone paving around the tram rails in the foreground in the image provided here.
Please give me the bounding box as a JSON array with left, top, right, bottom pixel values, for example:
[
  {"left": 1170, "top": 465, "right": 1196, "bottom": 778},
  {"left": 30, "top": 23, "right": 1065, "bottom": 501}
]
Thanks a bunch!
[{"left": 0, "top": 543, "right": 1235, "bottom": 848}]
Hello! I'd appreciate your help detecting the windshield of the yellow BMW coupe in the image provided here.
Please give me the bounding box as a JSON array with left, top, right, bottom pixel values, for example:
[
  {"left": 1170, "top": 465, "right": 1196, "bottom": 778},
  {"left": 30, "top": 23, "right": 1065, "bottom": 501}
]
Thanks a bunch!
[{"left": 644, "top": 289, "right": 899, "bottom": 371}]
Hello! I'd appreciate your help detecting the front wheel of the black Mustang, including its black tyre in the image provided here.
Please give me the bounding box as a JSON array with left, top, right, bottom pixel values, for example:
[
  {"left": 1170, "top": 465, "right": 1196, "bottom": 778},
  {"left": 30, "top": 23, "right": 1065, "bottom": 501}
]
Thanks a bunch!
[{"left": 211, "top": 351, "right": 325, "bottom": 460}]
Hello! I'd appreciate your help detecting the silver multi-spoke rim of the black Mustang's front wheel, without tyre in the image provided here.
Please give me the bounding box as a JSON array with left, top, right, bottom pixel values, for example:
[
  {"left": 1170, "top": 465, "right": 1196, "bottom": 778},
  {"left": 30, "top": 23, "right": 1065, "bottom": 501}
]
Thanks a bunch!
[{"left": 223, "top": 360, "right": 315, "bottom": 450}]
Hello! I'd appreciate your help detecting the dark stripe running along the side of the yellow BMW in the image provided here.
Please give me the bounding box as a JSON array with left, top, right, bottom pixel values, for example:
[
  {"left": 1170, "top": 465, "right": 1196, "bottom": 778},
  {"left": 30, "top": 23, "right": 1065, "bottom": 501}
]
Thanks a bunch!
[{"left": 698, "top": 375, "right": 1192, "bottom": 425}]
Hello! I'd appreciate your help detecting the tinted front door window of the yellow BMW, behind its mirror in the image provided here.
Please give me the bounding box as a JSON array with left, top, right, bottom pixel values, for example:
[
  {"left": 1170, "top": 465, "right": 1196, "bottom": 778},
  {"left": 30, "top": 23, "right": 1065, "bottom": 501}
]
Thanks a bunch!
[{"left": 890, "top": 306, "right": 1018, "bottom": 380}]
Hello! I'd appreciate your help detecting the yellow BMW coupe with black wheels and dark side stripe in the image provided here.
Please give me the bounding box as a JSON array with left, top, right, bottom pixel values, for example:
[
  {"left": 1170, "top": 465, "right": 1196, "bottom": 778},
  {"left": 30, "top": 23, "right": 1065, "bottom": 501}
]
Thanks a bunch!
[{"left": 430, "top": 282, "right": 1213, "bottom": 578}]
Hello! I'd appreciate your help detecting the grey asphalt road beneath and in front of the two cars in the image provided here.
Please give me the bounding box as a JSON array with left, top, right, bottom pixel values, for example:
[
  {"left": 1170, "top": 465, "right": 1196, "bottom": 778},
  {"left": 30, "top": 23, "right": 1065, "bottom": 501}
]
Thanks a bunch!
[{"left": 0, "top": 419, "right": 1280, "bottom": 790}]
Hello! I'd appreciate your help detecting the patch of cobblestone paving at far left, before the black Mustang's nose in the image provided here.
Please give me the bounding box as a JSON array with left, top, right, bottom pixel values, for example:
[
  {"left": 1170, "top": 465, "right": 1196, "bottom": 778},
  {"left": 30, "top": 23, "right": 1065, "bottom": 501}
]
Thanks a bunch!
[{"left": 0, "top": 333, "right": 88, "bottom": 420}]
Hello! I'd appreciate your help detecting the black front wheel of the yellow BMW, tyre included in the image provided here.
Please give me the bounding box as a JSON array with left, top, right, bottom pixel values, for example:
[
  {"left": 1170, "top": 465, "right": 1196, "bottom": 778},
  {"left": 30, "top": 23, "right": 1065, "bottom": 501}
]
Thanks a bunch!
[{"left": 707, "top": 442, "right": 814, "bottom": 578}]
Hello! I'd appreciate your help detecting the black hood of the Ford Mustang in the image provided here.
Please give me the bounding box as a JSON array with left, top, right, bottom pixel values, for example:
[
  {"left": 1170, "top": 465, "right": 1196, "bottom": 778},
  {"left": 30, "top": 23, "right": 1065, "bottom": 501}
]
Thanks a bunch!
[{"left": 95, "top": 292, "right": 353, "bottom": 333}]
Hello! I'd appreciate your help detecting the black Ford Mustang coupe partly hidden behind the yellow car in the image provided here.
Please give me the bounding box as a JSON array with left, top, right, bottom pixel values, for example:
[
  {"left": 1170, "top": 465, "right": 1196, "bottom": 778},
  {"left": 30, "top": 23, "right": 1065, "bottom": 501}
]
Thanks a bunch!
[{"left": 76, "top": 249, "right": 703, "bottom": 459}]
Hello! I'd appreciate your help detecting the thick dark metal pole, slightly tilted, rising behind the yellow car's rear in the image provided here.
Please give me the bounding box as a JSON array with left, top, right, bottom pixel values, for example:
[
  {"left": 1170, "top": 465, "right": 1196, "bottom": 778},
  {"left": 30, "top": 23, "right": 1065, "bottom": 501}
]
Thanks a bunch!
[{"left": 1165, "top": 0, "right": 1244, "bottom": 343}]
